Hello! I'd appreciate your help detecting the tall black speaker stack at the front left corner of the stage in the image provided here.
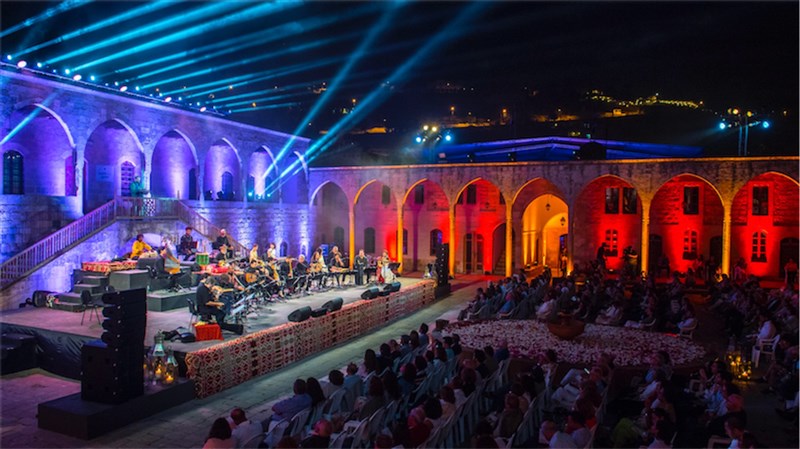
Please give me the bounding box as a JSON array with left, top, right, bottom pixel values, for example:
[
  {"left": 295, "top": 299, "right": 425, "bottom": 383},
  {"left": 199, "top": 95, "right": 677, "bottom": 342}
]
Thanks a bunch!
[{"left": 81, "top": 289, "right": 147, "bottom": 404}]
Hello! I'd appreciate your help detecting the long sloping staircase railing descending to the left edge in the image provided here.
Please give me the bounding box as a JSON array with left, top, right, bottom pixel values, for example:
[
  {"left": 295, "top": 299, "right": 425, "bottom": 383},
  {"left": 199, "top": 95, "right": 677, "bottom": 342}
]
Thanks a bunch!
[{"left": 0, "top": 200, "right": 117, "bottom": 290}]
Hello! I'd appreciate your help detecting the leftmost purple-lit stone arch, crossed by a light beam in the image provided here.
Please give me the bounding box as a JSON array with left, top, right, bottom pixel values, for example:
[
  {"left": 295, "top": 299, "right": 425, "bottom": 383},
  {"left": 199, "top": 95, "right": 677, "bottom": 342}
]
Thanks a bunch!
[{"left": 0, "top": 103, "right": 75, "bottom": 196}]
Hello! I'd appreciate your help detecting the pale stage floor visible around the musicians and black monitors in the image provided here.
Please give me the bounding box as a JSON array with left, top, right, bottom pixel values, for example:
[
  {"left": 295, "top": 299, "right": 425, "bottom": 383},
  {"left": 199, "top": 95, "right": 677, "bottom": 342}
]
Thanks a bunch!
[{"left": 0, "top": 273, "right": 422, "bottom": 353}]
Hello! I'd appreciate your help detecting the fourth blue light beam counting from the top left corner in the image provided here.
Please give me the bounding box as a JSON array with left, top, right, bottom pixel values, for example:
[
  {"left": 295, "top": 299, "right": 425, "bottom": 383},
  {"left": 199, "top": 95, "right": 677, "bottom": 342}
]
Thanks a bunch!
[{"left": 74, "top": 0, "right": 302, "bottom": 70}]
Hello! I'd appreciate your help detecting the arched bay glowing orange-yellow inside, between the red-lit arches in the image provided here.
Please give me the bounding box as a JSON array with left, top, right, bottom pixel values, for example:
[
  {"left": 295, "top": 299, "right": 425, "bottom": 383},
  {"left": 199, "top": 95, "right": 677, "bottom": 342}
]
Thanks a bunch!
[{"left": 511, "top": 179, "right": 569, "bottom": 276}]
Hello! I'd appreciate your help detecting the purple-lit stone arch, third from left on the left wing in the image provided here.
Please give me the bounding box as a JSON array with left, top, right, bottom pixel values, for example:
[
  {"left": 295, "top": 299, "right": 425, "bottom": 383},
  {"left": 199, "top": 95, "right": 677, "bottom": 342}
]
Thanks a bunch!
[{"left": 150, "top": 129, "right": 198, "bottom": 199}]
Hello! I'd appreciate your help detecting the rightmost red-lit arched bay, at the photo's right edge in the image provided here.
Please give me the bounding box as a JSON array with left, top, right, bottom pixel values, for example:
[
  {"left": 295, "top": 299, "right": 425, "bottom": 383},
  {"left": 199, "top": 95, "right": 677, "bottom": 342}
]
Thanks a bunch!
[{"left": 731, "top": 173, "right": 800, "bottom": 278}]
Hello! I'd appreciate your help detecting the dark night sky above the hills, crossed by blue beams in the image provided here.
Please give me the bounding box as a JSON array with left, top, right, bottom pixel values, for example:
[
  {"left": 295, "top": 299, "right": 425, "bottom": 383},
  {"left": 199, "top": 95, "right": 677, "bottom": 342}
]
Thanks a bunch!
[{"left": 0, "top": 0, "right": 799, "bottom": 137}]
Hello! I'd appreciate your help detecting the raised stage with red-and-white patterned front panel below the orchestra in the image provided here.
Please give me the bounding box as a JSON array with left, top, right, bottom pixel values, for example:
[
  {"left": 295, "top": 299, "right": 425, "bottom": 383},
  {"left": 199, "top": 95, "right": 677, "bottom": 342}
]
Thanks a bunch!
[{"left": 0, "top": 277, "right": 434, "bottom": 397}]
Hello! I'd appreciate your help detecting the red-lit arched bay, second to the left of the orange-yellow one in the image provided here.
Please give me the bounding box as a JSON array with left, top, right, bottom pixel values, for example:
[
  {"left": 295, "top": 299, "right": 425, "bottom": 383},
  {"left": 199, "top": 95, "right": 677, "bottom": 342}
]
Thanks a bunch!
[{"left": 403, "top": 179, "right": 450, "bottom": 271}]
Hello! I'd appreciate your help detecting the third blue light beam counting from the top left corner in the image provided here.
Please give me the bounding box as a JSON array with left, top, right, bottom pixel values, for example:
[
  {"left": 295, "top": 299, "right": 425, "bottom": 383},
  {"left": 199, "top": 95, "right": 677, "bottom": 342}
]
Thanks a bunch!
[{"left": 47, "top": 2, "right": 240, "bottom": 65}]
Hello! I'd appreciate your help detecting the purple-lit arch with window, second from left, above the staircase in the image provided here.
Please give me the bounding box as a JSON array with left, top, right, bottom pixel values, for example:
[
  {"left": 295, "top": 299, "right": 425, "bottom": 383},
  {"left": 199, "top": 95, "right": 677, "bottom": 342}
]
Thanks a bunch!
[{"left": 84, "top": 119, "right": 145, "bottom": 212}]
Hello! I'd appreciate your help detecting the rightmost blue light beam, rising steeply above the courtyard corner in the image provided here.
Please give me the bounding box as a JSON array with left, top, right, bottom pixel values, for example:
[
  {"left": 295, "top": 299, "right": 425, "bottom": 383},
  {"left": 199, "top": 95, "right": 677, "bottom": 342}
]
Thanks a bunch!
[{"left": 264, "top": 2, "right": 485, "bottom": 194}]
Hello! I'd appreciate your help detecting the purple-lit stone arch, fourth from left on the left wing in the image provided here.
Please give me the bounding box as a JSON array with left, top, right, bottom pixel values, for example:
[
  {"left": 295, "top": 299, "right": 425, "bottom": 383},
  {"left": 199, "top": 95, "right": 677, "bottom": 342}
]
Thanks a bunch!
[{"left": 203, "top": 138, "right": 242, "bottom": 201}]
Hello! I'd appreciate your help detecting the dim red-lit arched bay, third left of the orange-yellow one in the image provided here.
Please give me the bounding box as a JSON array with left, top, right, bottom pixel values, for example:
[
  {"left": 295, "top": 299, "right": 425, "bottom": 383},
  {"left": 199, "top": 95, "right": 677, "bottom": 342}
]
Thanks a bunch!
[{"left": 353, "top": 179, "right": 400, "bottom": 262}]
